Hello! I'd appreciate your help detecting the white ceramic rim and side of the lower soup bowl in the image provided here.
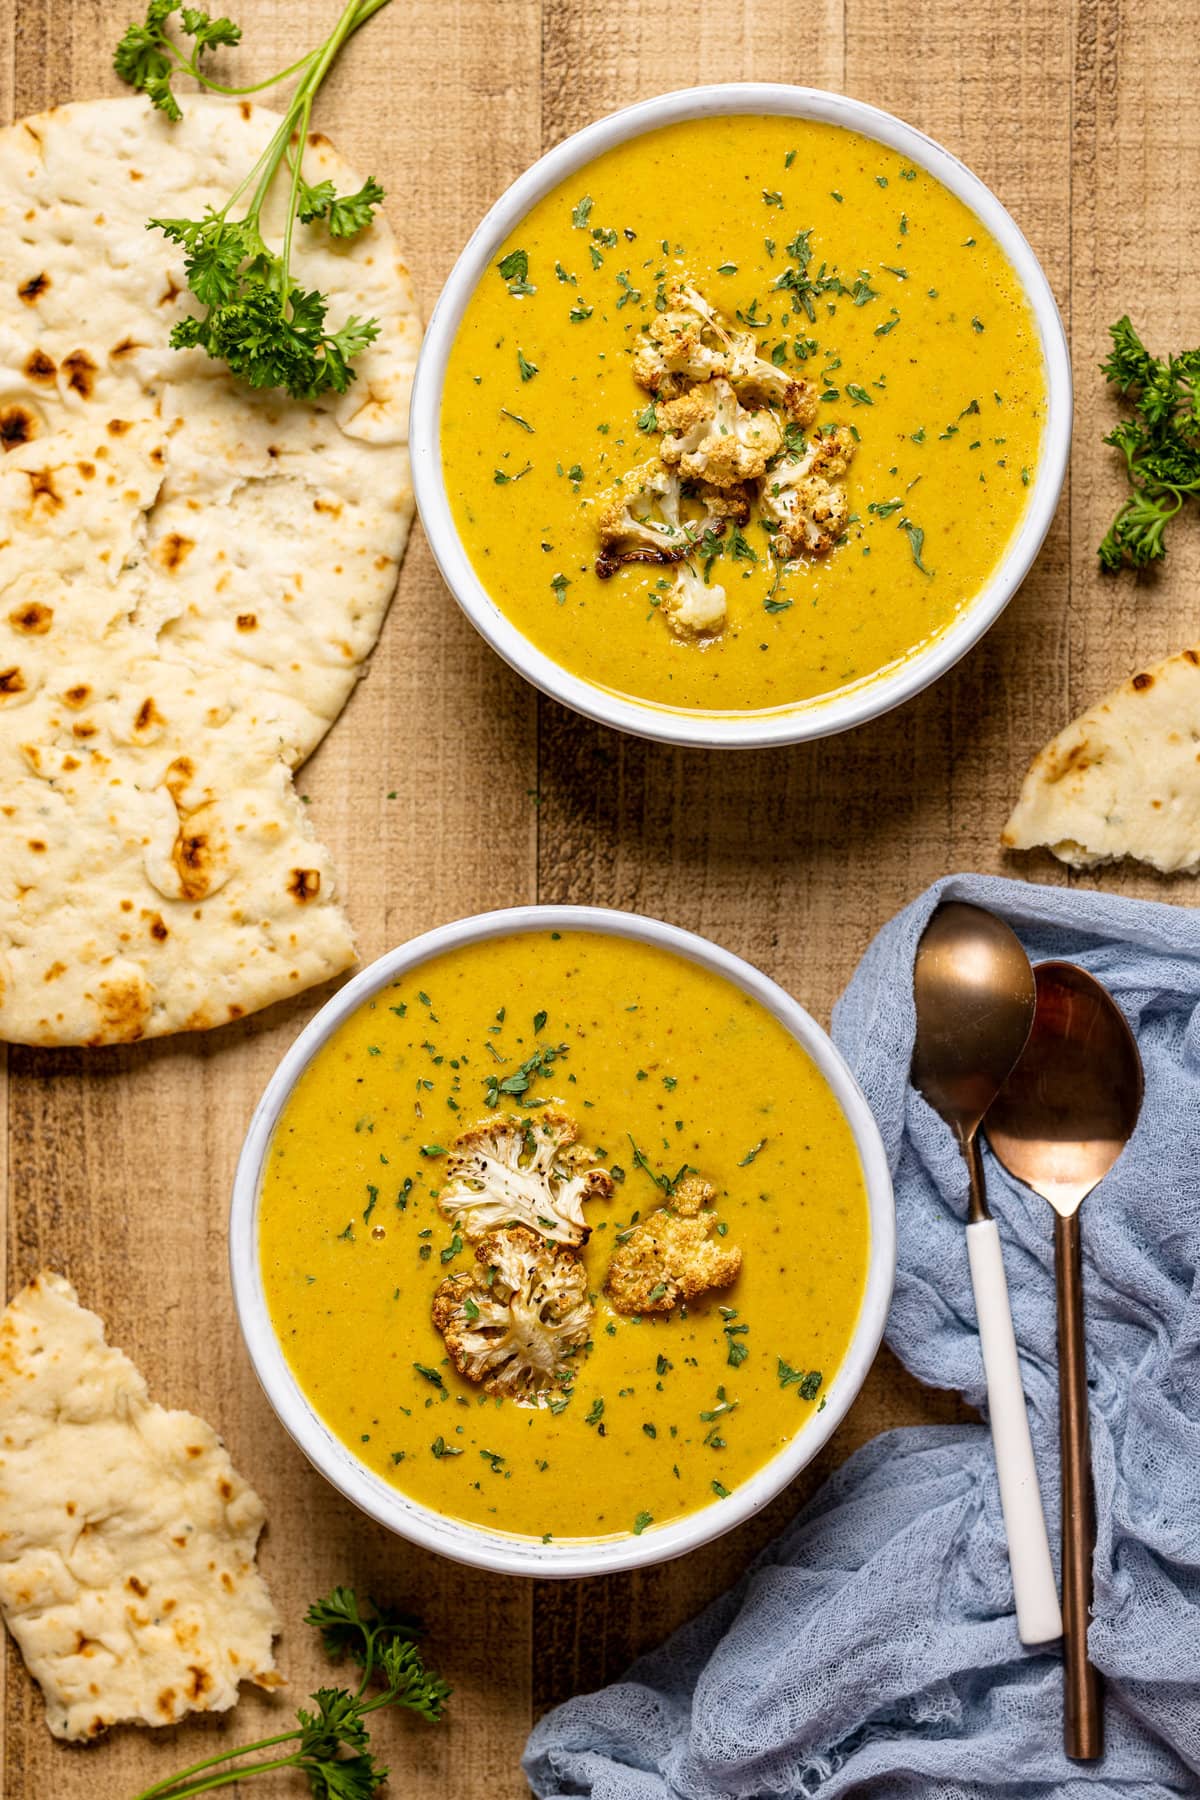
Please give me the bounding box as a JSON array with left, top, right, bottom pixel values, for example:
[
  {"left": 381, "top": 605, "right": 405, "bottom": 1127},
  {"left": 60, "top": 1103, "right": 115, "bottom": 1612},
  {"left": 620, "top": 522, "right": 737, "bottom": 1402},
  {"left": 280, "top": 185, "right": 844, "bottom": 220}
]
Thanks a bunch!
[{"left": 228, "top": 905, "right": 896, "bottom": 1577}]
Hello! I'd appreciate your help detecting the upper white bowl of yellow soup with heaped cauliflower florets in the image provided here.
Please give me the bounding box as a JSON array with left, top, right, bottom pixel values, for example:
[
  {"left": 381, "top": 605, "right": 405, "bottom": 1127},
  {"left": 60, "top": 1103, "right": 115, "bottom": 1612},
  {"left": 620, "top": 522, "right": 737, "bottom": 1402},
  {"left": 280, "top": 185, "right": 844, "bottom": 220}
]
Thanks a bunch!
[{"left": 412, "top": 85, "right": 1072, "bottom": 747}]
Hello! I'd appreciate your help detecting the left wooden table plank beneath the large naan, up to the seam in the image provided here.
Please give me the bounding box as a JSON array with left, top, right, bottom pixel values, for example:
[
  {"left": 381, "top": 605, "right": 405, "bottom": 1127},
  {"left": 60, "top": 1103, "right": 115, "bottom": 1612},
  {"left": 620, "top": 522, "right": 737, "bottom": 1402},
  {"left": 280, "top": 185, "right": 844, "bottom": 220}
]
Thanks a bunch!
[{"left": 0, "top": 0, "right": 542, "bottom": 1800}]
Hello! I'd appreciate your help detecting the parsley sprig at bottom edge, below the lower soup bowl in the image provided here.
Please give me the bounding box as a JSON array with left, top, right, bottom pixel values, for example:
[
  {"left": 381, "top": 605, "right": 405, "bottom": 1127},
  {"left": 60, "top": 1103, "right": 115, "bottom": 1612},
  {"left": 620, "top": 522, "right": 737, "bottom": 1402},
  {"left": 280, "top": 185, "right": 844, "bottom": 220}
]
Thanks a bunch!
[{"left": 127, "top": 1588, "right": 450, "bottom": 1800}]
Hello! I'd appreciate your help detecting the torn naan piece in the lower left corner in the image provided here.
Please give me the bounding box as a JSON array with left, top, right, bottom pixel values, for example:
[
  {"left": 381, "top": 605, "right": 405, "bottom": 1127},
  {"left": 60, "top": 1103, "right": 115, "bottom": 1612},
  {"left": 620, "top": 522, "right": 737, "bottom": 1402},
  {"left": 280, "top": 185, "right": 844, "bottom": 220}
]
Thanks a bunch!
[{"left": 0, "top": 1271, "right": 281, "bottom": 1739}]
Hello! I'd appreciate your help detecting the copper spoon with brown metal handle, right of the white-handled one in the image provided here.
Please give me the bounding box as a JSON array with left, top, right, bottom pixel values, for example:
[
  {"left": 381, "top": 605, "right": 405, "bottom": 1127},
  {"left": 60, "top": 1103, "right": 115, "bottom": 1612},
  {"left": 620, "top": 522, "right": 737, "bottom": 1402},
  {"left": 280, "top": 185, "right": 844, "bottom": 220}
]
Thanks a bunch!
[{"left": 984, "top": 963, "right": 1142, "bottom": 1762}]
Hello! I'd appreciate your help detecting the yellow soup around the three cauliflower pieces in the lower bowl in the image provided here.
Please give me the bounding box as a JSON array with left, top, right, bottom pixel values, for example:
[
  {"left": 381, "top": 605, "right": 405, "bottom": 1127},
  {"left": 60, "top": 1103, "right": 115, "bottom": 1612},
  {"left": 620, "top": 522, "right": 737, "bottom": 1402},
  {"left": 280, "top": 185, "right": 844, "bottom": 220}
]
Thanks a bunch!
[{"left": 259, "top": 932, "right": 869, "bottom": 1539}]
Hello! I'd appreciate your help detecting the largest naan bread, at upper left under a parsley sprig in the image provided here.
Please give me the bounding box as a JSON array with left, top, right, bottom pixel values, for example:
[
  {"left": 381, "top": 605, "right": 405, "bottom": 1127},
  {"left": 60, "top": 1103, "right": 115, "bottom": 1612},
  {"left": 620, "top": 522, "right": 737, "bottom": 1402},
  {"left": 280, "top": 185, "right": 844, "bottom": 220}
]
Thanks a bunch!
[{"left": 0, "top": 97, "right": 421, "bottom": 1044}]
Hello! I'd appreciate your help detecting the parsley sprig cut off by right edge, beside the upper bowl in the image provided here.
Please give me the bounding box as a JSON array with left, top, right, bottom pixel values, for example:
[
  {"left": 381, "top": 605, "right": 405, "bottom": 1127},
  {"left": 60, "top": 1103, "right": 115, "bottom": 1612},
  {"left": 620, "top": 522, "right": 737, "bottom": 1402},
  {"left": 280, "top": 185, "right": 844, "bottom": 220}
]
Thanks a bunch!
[{"left": 1099, "top": 315, "right": 1200, "bottom": 571}]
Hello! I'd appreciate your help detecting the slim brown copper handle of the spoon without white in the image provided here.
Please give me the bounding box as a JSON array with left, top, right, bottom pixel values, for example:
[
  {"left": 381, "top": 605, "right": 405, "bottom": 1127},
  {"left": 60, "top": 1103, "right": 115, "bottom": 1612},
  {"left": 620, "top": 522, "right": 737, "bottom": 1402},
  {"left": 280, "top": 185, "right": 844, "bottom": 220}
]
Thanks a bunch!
[{"left": 1054, "top": 1213, "right": 1105, "bottom": 1762}]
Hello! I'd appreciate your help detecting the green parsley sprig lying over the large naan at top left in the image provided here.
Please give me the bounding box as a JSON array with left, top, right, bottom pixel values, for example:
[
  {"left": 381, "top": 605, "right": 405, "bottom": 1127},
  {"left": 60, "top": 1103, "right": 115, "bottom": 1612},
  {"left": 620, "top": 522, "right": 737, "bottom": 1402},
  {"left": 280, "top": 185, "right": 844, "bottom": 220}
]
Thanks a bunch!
[{"left": 113, "top": 0, "right": 387, "bottom": 400}]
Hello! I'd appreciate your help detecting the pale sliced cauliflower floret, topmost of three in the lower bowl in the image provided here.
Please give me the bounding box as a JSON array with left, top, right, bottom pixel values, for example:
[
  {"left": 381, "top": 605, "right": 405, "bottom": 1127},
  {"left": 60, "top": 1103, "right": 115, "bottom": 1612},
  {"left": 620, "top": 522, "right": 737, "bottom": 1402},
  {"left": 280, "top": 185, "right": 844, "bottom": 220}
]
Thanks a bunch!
[{"left": 437, "top": 1112, "right": 612, "bottom": 1244}]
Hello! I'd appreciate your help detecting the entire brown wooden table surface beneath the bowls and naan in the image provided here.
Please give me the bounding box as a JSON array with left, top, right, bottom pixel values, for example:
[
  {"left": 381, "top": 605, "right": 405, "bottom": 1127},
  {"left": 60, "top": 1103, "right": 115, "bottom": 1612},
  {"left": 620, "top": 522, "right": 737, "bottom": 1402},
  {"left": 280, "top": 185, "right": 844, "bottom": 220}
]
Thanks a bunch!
[{"left": 0, "top": 0, "right": 1200, "bottom": 1800}]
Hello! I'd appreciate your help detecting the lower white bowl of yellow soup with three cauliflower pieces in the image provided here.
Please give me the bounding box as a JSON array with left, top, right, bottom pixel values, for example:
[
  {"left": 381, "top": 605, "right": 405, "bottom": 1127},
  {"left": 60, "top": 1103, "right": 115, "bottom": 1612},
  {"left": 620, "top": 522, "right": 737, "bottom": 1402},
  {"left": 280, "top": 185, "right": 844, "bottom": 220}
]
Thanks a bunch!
[{"left": 230, "top": 907, "right": 896, "bottom": 1577}]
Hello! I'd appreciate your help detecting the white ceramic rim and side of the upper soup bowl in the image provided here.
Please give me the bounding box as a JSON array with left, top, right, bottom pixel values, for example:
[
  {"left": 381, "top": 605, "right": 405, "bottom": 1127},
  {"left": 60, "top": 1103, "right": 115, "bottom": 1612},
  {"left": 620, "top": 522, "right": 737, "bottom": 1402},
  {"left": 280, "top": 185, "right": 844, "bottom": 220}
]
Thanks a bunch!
[{"left": 410, "top": 81, "right": 1072, "bottom": 747}]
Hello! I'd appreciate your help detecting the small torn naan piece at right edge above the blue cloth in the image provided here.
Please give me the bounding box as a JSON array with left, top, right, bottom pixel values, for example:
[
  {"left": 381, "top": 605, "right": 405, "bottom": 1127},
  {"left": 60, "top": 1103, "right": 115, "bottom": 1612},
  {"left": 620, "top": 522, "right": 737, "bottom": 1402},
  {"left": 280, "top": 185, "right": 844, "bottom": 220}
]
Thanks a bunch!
[{"left": 1002, "top": 648, "right": 1200, "bottom": 875}]
